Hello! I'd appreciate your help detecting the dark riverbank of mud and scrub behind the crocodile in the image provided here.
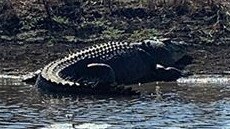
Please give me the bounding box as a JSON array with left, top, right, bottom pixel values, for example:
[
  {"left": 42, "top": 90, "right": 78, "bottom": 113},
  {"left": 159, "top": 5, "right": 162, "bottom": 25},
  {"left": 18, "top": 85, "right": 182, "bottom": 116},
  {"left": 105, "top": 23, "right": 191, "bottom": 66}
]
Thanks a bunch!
[{"left": 0, "top": 0, "right": 230, "bottom": 74}]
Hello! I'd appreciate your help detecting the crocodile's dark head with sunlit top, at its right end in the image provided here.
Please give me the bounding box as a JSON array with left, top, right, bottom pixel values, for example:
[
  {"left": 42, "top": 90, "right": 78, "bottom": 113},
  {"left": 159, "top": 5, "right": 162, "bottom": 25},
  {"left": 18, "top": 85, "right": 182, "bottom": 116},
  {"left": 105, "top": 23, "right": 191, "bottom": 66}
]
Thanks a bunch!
[{"left": 143, "top": 40, "right": 187, "bottom": 66}]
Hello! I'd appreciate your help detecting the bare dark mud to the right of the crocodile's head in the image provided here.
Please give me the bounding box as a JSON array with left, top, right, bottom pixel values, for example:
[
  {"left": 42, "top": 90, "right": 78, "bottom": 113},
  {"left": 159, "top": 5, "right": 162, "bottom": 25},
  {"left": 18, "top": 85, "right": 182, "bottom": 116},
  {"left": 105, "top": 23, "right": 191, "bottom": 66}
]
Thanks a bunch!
[{"left": 185, "top": 44, "right": 230, "bottom": 74}]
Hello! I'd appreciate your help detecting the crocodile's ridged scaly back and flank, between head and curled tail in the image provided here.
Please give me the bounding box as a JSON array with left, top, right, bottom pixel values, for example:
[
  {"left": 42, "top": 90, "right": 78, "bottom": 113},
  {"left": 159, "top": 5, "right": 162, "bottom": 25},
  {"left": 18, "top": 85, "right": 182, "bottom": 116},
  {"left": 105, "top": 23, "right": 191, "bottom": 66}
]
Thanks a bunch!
[{"left": 41, "top": 42, "right": 149, "bottom": 85}]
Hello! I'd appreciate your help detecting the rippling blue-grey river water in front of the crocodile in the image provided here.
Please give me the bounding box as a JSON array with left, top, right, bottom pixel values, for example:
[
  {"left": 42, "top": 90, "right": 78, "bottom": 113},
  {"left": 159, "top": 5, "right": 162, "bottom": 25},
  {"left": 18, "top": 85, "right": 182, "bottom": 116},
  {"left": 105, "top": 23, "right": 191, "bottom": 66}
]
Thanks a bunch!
[{"left": 0, "top": 76, "right": 230, "bottom": 129}]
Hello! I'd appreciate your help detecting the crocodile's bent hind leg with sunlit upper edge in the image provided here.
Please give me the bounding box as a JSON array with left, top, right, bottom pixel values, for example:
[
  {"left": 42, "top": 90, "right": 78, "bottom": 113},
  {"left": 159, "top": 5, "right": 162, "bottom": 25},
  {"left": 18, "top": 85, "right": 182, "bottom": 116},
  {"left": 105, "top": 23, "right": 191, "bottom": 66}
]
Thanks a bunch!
[{"left": 80, "top": 63, "right": 115, "bottom": 87}]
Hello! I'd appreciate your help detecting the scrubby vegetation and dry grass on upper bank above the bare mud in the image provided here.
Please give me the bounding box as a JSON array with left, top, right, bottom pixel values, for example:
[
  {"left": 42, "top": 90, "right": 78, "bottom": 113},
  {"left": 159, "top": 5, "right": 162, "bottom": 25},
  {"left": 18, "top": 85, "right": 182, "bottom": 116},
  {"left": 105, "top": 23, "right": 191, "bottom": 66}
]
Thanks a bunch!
[{"left": 0, "top": 0, "right": 230, "bottom": 44}]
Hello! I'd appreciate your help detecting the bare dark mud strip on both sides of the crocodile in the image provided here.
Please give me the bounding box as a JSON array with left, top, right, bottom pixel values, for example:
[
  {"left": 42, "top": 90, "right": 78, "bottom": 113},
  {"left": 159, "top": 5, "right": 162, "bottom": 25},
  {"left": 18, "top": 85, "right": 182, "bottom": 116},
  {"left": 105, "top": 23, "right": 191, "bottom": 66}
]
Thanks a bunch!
[{"left": 0, "top": 40, "right": 230, "bottom": 74}]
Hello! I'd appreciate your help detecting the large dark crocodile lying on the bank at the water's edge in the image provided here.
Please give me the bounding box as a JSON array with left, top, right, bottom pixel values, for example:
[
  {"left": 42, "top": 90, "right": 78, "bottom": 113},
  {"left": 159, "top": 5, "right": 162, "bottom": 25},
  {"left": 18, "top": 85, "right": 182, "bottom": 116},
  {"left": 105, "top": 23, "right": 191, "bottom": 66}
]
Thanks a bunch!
[{"left": 22, "top": 40, "right": 190, "bottom": 94}]
